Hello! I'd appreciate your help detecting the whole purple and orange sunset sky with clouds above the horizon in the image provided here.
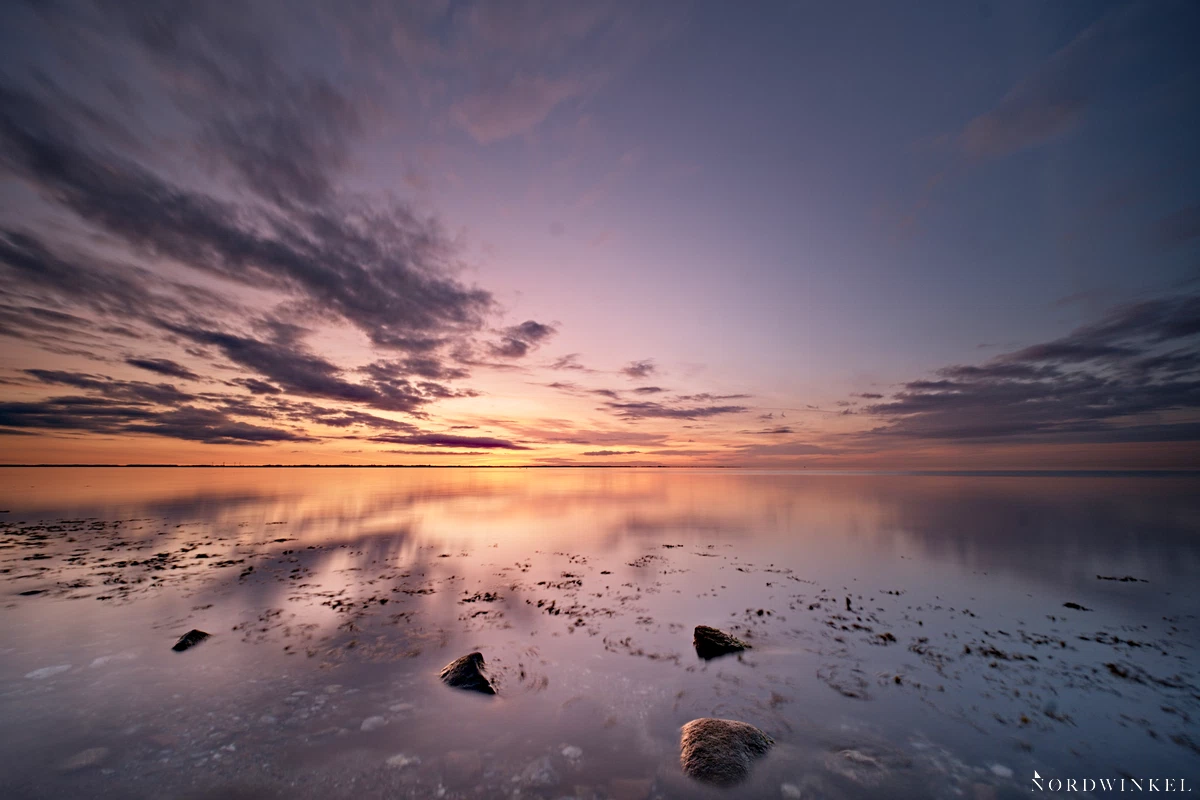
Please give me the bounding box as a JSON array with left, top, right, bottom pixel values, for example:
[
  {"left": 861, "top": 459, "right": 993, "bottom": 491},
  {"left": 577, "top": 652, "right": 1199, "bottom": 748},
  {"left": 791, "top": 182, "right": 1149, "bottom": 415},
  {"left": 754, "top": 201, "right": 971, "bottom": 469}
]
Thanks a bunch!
[{"left": 0, "top": 0, "right": 1200, "bottom": 469}]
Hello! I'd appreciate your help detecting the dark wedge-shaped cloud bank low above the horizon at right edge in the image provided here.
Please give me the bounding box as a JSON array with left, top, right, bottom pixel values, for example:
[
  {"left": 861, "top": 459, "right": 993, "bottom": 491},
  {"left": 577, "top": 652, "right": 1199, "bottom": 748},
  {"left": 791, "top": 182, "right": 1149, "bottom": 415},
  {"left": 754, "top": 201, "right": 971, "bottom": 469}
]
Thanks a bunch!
[{"left": 863, "top": 295, "right": 1200, "bottom": 444}]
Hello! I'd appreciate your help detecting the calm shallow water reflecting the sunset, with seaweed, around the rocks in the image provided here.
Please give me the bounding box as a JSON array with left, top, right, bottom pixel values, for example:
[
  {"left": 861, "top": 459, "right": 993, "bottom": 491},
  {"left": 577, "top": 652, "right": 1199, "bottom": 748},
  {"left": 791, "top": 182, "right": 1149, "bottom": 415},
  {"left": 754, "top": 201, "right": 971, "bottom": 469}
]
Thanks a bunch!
[{"left": 0, "top": 468, "right": 1200, "bottom": 800}]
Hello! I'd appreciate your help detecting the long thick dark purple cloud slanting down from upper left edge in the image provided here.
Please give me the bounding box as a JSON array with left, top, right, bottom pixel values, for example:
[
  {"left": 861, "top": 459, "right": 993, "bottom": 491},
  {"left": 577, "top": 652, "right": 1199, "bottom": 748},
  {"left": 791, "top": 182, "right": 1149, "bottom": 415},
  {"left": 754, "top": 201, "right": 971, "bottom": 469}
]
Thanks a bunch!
[{"left": 0, "top": 82, "right": 493, "bottom": 351}]
